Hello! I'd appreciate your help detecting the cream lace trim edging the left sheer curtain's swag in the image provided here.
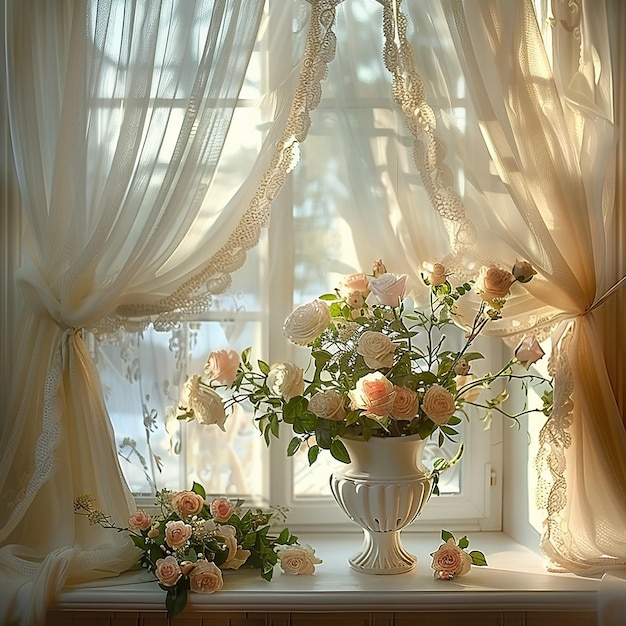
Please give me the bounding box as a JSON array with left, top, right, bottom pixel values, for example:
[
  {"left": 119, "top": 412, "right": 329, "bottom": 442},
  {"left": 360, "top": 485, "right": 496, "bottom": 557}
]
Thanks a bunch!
[{"left": 90, "top": 0, "right": 343, "bottom": 334}]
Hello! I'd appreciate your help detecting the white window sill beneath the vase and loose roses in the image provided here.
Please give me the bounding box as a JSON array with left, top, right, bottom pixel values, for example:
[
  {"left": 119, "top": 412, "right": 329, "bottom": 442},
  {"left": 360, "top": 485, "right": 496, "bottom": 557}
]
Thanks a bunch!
[{"left": 56, "top": 533, "right": 600, "bottom": 613}]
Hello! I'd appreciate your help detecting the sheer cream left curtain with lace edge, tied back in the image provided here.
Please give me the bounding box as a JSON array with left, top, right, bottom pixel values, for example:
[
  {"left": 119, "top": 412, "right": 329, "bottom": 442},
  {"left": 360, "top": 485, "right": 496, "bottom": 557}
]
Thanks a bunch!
[{"left": 0, "top": 0, "right": 332, "bottom": 624}]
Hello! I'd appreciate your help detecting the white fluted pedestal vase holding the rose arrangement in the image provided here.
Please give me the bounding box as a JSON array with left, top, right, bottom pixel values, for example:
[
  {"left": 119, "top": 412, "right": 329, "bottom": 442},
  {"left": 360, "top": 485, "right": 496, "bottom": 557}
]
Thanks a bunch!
[{"left": 330, "top": 435, "right": 431, "bottom": 574}]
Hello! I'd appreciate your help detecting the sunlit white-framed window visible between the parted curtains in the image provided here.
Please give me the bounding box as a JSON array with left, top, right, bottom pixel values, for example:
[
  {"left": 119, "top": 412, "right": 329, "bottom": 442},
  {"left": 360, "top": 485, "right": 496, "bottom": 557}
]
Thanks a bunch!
[{"left": 98, "top": 0, "right": 501, "bottom": 530}]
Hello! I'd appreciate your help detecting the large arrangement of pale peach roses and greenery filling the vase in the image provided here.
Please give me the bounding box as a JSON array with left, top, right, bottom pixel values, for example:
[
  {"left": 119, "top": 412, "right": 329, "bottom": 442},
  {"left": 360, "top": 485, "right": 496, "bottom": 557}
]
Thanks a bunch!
[{"left": 177, "top": 261, "right": 551, "bottom": 469}]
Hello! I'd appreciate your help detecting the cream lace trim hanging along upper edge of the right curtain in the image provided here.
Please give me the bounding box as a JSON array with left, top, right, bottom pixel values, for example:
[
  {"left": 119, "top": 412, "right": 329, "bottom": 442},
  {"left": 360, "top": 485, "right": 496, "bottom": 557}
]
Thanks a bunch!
[{"left": 379, "top": 0, "right": 476, "bottom": 266}]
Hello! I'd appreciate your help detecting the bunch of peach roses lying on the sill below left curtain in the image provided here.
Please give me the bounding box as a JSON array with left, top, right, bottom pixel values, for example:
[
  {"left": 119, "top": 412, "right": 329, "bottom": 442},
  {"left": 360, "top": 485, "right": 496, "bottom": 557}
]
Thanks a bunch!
[{"left": 74, "top": 483, "right": 322, "bottom": 620}]
